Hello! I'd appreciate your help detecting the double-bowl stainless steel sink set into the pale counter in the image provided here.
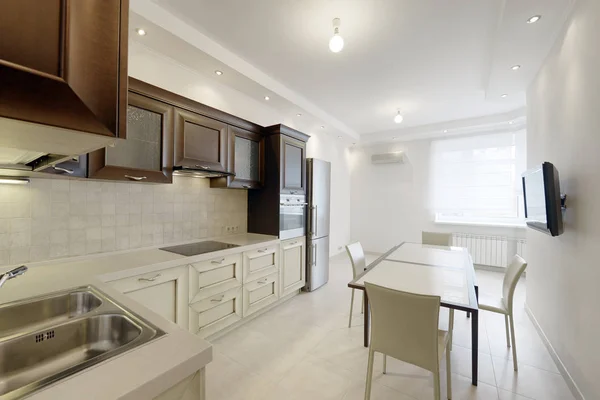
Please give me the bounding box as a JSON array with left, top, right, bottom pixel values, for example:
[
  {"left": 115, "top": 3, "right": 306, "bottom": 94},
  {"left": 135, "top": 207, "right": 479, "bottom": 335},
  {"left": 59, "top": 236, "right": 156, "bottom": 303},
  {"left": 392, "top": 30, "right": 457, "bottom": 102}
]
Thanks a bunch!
[{"left": 0, "top": 286, "right": 164, "bottom": 400}]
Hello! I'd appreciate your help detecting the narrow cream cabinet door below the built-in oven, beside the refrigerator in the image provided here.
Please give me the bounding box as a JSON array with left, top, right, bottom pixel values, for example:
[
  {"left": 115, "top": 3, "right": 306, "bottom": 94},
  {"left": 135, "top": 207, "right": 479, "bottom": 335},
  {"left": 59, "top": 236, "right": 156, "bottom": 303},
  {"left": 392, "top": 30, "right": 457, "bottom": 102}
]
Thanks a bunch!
[{"left": 279, "top": 237, "right": 306, "bottom": 297}]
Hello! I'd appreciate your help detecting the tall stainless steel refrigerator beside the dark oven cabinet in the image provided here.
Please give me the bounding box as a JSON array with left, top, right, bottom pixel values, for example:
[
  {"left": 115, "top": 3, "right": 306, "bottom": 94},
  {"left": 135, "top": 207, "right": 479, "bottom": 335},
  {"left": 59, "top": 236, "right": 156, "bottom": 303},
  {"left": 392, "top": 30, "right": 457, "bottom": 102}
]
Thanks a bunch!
[{"left": 305, "top": 158, "right": 331, "bottom": 292}]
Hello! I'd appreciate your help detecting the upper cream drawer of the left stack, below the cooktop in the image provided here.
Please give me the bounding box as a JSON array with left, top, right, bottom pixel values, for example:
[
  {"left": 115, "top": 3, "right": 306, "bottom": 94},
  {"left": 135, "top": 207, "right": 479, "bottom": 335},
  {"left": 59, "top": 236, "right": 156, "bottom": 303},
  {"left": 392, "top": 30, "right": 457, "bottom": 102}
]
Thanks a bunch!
[{"left": 189, "top": 254, "right": 242, "bottom": 303}]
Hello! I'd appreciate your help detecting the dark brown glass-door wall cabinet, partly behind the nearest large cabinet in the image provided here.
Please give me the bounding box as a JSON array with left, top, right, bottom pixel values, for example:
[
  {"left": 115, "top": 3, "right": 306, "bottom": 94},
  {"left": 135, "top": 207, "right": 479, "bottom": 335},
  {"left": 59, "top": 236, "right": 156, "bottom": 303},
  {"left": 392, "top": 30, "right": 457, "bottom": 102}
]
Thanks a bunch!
[{"left": 88, "top": 92, "right": 173, "bottom": 183}]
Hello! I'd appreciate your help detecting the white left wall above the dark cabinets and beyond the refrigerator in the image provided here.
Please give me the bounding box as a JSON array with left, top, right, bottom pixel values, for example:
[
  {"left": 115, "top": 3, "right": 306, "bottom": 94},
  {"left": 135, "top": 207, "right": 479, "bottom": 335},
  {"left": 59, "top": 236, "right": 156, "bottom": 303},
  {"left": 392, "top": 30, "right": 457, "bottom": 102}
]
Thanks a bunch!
[{"left": 129, "top": 42, "right": 350, "bottom": 255}]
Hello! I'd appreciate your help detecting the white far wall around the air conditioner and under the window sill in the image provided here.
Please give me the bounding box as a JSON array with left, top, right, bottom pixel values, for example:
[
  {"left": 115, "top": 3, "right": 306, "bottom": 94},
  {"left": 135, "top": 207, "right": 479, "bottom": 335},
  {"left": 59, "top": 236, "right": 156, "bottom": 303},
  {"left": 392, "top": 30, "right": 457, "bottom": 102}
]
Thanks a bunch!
[{"left": 350, "top": 140, "right": 524, "bottom": 252}]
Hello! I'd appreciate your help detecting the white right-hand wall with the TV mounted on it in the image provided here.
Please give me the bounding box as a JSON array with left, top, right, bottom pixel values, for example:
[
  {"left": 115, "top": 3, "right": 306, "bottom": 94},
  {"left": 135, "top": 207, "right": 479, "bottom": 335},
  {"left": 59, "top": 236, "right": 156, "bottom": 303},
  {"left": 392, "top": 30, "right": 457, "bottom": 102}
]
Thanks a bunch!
[{"left": 527, "top": 0, "right": 600, "bottom": 399}]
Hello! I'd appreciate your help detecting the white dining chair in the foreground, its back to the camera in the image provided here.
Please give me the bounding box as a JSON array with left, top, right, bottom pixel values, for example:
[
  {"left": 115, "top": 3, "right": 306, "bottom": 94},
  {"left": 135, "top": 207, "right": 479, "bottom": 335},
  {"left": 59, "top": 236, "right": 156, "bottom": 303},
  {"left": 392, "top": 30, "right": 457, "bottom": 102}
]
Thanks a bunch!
[{"left": 365, "top": 282, "right": 454, "bottom": 400}]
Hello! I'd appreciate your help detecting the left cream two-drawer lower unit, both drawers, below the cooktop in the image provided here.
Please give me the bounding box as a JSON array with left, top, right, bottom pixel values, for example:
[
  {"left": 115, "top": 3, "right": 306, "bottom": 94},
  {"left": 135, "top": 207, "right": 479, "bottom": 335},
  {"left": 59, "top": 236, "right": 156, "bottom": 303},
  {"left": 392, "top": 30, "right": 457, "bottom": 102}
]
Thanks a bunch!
[{"left": 189, "top": 254, "right": 243, "bottom": 337}]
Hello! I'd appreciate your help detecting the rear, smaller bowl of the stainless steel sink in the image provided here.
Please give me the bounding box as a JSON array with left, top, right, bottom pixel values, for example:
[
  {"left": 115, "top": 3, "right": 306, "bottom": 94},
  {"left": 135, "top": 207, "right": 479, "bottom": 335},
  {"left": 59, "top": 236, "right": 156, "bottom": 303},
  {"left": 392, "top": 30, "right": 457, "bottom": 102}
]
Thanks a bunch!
[{"left": 0, "top": 288, "right": 102, "bottom": 337}]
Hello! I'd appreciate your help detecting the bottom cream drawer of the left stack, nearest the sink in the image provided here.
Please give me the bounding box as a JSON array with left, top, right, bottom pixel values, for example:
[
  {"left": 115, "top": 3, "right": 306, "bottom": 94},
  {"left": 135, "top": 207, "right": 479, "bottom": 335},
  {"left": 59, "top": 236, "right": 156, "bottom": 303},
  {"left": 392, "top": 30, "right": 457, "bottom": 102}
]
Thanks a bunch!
[{"left": 189, "top": 287, "right": 242, "bottom": 337}]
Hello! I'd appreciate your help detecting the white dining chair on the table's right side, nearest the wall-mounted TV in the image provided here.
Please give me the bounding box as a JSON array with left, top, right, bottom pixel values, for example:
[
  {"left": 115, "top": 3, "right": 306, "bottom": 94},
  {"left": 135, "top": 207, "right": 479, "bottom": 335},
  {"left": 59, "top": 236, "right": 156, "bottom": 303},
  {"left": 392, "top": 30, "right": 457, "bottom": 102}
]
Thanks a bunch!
[{"left": 479, "top": 255, "right": 527, "bottom": 371}]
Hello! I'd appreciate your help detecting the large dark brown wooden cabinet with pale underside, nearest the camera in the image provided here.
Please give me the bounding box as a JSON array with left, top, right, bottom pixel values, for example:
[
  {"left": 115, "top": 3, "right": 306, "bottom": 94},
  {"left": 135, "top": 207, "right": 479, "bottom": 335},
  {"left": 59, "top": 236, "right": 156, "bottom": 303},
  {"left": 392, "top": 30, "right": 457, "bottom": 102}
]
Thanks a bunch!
[{"left": 0, "top": 0, "right": 129, "bottom": 154}]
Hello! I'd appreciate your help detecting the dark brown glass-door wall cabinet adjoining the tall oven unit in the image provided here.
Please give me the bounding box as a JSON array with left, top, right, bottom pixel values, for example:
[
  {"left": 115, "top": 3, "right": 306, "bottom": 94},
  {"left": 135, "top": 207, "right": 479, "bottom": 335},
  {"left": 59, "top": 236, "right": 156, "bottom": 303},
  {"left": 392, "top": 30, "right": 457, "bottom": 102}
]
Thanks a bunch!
[{"left": 210, "top": 126, "right": 265, "bottom": 189}]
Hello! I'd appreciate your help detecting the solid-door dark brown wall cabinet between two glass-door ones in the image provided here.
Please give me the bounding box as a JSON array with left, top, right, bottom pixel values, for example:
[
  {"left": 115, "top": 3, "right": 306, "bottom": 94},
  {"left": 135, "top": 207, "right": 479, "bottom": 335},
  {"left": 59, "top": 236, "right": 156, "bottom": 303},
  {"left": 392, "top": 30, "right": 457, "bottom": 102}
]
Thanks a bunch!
[{"left": 175, "top": 108, "right": 227, "bottom": 171}]
